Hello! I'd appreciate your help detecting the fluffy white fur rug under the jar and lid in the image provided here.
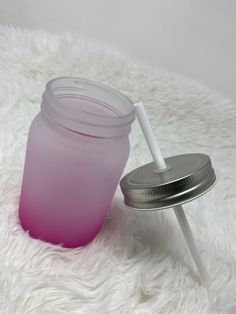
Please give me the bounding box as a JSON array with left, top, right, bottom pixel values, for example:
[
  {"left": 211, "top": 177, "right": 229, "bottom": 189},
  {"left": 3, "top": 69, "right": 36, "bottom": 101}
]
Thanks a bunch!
[{"left": 0, "top": 27, "right": 236, "bottom": 314}]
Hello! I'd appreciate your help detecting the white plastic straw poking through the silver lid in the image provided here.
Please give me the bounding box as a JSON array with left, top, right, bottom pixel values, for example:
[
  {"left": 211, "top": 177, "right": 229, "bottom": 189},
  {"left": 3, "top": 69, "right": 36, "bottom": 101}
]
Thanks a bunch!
[{"left": 134, "top": 102, "right": 210, "bottom": 285}]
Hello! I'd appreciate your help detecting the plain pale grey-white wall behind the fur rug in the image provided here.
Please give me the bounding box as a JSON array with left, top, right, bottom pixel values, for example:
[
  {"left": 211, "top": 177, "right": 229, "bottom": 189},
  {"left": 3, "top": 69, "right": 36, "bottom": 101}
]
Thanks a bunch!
[{"left": 0, "top": 0, "right": 236, "bottom": 99}]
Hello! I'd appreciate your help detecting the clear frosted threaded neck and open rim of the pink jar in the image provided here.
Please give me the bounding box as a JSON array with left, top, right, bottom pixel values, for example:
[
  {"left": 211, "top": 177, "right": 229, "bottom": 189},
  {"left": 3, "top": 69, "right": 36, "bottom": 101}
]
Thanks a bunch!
[{"left": 41, "top": 77, "right": 135, "bottom": 138}]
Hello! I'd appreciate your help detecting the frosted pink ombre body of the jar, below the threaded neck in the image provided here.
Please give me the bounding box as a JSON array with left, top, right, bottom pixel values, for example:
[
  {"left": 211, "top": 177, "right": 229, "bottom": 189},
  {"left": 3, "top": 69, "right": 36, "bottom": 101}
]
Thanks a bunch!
[{"left": 19, "top": 113, "right": 129, "bottom": 247}]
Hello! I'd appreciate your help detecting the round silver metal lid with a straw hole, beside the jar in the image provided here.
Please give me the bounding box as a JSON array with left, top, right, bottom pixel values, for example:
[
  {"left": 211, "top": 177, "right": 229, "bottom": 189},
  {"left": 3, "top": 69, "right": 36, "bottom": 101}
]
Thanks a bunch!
[{"left": 120, "top": 154, "right": 216, "bottom": 210}]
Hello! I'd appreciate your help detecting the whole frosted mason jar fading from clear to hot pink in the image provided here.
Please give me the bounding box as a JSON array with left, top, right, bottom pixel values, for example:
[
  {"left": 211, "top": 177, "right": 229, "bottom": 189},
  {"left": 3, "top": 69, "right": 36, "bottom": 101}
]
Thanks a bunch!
[{"left": 19, "top": 77, "right": 135, "bottom": 247}]
